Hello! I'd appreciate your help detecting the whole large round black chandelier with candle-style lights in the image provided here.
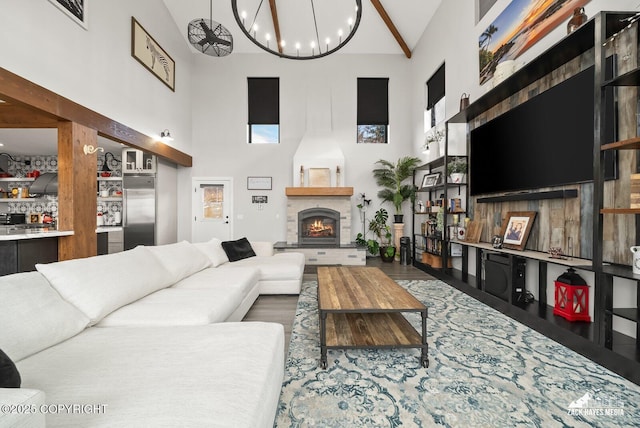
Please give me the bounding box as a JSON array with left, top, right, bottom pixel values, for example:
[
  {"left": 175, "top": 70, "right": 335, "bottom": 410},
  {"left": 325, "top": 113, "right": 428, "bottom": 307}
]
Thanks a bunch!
[{"left": 231, "top": 0, "right": 362, "bottom": 59}]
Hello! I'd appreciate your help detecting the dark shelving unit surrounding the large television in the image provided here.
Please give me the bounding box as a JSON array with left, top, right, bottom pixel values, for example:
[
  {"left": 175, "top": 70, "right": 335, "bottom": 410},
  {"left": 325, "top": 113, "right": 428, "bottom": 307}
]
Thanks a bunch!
[{"left": 414, "top": 11, "right": 640, "bottom": 384}]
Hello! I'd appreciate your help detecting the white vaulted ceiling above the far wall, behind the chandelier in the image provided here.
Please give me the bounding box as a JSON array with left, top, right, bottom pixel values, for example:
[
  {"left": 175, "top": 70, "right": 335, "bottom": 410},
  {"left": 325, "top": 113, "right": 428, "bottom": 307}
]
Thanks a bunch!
[{"left": 163, "top": 0, "right": 441, "bottom": 55}]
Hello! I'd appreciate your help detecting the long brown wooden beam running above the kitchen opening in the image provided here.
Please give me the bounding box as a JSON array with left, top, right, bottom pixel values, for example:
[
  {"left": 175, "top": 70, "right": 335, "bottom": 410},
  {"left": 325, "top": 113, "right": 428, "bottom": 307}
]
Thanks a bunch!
[{"left": 0, "top": 67, "right": 193, "bottom": 167}]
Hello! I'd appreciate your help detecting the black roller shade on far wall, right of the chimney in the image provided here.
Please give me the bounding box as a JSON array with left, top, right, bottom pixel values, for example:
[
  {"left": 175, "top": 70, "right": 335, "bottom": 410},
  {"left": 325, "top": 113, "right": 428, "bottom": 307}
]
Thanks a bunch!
[{"left": 358, "top": 77, "right": 389, "bottom": 125}]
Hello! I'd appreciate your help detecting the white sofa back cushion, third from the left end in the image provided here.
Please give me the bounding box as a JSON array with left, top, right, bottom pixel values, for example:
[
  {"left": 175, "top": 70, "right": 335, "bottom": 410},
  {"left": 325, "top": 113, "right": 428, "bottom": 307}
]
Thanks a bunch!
[{"left": 146, "top": 241, "right": 211, "bottom": 284}]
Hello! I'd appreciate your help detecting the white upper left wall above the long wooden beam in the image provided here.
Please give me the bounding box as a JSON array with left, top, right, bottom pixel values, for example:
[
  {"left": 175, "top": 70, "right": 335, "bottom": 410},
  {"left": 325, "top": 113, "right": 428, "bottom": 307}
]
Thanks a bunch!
[{"left": 0, "top": 0, "right": 193, "bottom": 153}]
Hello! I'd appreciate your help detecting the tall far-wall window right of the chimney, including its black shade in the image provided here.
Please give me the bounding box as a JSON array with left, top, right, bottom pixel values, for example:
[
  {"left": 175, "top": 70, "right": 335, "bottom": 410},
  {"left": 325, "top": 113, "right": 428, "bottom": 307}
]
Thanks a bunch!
[{"left": 358, "top": 77, "right": 389, "bottom": 144}]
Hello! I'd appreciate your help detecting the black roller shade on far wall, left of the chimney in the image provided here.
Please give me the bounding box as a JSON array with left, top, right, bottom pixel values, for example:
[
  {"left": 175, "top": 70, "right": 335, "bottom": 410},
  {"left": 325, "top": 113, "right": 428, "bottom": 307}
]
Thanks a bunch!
[{"left": 247, "top": 77, "right": 280, "bottom": 125}]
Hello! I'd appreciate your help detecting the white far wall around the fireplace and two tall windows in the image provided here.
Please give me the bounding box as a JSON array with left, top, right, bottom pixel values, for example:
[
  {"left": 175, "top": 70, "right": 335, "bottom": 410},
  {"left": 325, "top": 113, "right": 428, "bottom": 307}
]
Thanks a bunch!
[{"left": 184, "top": 54, "right": 411, "bottom": 241}]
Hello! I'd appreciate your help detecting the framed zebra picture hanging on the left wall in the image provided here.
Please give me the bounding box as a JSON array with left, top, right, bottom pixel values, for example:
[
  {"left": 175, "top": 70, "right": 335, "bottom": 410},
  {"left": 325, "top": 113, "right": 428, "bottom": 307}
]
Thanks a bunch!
[{"left": 131, "top": 16, "right": 176, "bottom": 92}]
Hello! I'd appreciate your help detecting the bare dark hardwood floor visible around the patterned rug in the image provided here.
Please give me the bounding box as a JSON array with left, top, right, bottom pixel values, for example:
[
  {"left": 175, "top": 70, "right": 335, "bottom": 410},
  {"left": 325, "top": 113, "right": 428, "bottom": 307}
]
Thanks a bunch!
[{"left": 243, "top": 257, "right": 434, "bottom": 355}]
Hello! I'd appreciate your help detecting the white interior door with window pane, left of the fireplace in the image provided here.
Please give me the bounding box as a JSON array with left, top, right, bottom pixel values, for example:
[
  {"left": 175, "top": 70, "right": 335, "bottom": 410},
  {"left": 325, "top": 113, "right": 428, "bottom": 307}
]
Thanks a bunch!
[{"left": 191, "top": 178, "right": 233, "bottom": 242}]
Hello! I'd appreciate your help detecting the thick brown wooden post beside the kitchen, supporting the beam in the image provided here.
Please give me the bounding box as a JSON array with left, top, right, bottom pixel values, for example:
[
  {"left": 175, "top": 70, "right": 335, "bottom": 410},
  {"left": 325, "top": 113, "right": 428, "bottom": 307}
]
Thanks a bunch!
[{"left": 58, "top": 122, "right": 98, "bottom": 260}]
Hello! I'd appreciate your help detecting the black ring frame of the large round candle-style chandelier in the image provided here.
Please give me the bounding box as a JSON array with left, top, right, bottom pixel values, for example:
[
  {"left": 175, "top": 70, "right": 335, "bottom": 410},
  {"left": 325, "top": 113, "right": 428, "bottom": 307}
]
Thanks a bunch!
[{"left": 231, "top": 0, "right": 362, "bottom": 60}]
